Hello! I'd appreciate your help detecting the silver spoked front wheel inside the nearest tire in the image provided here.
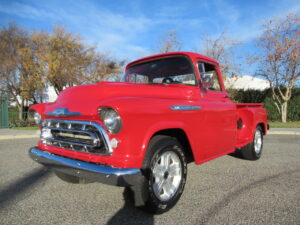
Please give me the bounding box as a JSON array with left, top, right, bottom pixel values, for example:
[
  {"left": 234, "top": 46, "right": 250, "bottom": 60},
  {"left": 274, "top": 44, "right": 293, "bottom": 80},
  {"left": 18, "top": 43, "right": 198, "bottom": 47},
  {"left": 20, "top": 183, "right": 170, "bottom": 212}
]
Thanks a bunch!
[{"left": 152, "top": 151, "right": 182, "bottom": 201}]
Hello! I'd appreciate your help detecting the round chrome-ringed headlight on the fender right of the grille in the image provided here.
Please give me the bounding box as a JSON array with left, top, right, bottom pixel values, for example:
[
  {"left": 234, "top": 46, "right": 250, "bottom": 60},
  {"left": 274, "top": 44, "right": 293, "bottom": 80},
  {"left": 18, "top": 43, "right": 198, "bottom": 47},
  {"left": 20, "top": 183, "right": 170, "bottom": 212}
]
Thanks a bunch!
[{"left": 98, "top": 107, "right": 122, "bottom": 134}]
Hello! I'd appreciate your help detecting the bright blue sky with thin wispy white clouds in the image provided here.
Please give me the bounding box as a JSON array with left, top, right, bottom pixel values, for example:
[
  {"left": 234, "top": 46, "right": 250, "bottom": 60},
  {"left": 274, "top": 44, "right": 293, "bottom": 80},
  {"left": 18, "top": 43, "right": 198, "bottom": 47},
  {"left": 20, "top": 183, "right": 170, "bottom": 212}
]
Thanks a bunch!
[{"left": 0, "top": 0, "right": 300, "bottom": 72}]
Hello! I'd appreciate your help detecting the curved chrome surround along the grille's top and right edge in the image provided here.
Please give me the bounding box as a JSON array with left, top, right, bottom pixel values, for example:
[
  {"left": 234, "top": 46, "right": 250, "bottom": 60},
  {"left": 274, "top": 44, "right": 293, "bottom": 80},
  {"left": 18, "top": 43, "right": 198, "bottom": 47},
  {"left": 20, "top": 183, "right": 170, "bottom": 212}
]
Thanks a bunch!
[{"left": 45, "top": 119, "right": 113, "bottom": 155}]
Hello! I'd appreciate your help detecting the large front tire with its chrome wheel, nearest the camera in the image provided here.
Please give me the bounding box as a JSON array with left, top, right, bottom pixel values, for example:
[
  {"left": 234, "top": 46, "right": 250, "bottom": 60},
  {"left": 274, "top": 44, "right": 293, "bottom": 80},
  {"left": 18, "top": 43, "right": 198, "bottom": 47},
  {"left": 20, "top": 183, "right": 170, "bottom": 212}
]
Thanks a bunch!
[{"left": 142, "top": 135, "right": 187, "bottom": 214}]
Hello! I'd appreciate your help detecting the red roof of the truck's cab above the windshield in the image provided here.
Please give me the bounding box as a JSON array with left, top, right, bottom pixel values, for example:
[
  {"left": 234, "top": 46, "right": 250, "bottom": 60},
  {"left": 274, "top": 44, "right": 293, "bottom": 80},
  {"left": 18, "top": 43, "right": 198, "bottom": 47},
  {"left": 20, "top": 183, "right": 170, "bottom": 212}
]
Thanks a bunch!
[{"left": 126, "top": 52, "right": 219, "bottom": 70}]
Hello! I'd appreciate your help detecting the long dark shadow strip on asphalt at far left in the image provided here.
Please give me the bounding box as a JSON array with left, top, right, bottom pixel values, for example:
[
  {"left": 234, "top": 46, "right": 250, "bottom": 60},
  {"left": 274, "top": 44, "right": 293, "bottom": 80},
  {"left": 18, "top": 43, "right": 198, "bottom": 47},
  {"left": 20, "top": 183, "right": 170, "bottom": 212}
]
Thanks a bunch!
[{"left": 0, "top": 167, "right": 50, "bottom": 210}]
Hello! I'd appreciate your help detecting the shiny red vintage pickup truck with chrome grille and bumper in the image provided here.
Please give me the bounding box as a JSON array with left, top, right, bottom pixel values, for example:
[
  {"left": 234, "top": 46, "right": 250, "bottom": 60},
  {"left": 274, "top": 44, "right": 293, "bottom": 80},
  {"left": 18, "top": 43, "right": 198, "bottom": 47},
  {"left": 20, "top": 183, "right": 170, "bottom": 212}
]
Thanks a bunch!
[{"left": 29, "top": 52, "right": 267, "bottom": 213}]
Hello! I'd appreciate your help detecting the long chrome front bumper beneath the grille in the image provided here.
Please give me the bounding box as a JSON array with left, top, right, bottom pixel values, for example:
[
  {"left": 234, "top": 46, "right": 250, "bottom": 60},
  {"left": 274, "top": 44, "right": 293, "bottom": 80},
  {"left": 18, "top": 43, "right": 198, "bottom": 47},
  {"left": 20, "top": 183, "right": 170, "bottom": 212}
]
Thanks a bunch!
[{"left": 29, "top": 147, "right": 144, "bottom": 187}]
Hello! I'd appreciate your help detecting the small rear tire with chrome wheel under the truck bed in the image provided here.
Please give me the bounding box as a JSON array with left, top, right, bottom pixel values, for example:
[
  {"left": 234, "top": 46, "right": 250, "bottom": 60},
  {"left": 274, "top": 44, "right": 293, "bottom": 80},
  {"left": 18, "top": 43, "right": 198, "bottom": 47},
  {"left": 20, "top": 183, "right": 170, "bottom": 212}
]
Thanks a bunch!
[{"left": 241, "top": 126, "right": 263, "bottom": 160}]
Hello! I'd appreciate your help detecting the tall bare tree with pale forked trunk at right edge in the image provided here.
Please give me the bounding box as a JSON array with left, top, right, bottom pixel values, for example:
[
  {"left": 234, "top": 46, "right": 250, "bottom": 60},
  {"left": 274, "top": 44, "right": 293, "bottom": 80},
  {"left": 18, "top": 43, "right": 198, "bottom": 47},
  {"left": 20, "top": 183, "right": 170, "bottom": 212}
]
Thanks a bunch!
[{"left": 251, "top": 14, "right": 300, "bottom": 123}]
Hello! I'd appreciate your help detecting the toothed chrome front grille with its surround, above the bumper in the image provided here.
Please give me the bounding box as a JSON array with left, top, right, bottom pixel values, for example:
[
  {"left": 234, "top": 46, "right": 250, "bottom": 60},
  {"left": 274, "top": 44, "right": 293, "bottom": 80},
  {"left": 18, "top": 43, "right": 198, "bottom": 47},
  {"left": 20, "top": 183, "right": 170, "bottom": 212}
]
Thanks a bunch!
[{"left": 41, "top": 119, "right": 112, "bottom": 155}]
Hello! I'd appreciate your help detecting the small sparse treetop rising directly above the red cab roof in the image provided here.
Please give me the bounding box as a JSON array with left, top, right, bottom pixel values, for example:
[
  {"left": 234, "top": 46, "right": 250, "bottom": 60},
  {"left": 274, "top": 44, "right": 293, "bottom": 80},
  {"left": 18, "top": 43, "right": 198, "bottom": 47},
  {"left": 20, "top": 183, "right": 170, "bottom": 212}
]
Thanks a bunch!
[{"left": 159, "top": 30, "right": 182, "bottom": 53}]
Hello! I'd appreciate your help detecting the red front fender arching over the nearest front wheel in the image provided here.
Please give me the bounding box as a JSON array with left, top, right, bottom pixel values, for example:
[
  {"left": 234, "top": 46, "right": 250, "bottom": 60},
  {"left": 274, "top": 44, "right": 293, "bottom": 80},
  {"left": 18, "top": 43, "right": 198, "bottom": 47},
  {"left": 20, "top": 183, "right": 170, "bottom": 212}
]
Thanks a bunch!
[{"left": 103, "top": 98, "right": 197, "bottom": 168}]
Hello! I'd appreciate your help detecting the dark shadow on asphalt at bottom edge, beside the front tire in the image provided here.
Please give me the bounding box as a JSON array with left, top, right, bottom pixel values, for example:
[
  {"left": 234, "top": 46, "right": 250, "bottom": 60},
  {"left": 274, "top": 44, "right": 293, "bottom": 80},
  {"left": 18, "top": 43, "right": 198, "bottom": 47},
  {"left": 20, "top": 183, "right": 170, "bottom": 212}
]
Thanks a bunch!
[{"left": 106, "top": 188, "right": 154, "bottom": 225}]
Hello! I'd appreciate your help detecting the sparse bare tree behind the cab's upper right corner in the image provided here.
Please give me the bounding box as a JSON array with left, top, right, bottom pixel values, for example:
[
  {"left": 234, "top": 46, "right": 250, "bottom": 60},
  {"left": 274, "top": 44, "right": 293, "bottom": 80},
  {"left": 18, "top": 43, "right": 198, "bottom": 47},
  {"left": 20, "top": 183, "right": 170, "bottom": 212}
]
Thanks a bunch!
[{"left": 200, "top": 32, "right": 242, "bottom": 78}]
